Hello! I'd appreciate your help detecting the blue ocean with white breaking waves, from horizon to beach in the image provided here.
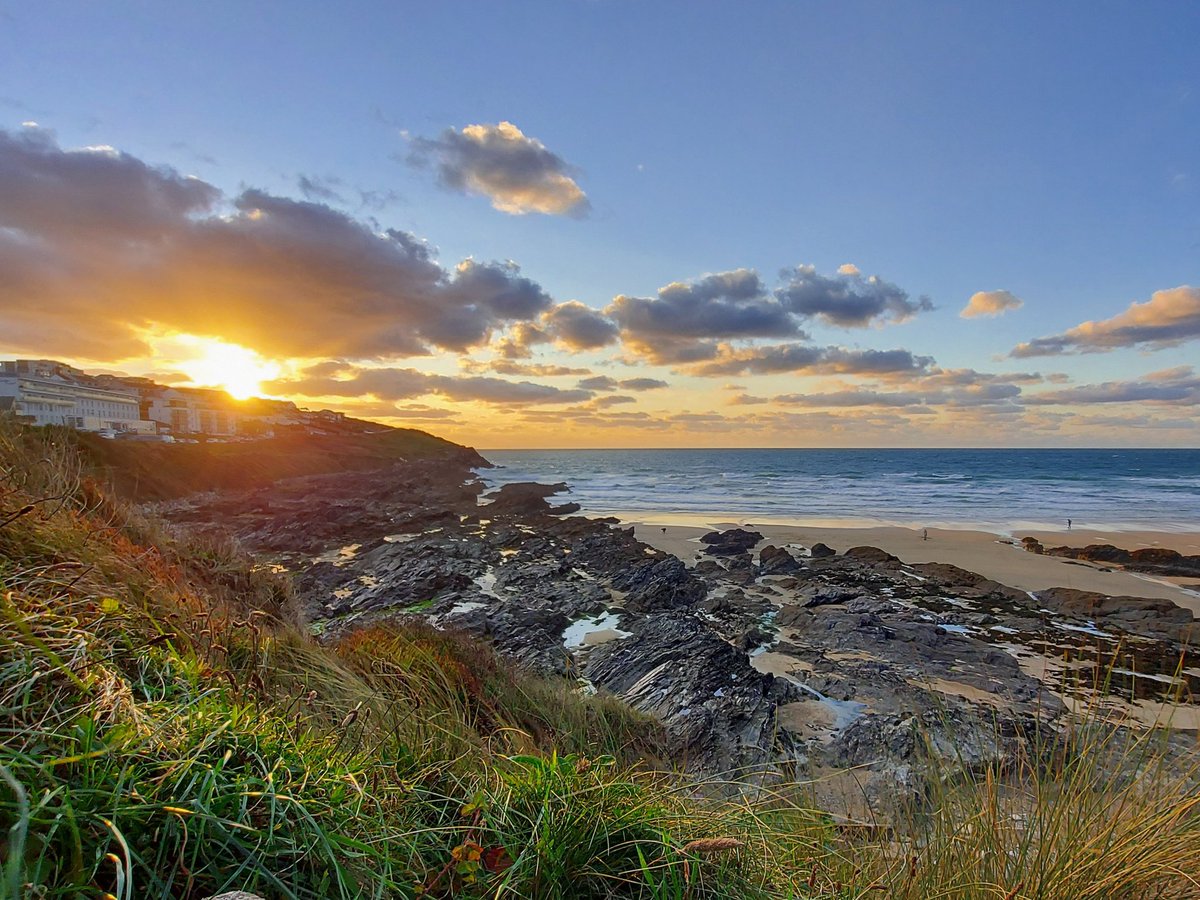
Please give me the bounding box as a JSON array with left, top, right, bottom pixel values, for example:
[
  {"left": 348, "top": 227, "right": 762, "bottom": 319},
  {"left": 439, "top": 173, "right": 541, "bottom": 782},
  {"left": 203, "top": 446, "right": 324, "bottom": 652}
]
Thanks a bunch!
[{"left": 480, "top": 450, "right": 1200, "bottom": 532}]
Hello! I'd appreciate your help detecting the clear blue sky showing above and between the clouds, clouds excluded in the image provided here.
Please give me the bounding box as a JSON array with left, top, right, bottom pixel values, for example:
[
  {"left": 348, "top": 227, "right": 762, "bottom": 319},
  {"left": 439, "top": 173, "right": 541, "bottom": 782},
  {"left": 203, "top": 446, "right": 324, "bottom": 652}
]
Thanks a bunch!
[{"left": 0, "top": 0, "right": 1200, "bottom": 445}]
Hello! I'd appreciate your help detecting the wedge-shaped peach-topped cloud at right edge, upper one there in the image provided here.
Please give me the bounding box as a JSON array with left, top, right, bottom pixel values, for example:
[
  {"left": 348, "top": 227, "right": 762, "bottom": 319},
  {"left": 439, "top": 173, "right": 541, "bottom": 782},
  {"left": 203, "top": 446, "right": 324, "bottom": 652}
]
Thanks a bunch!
[{"left": 1009, "top": 284, "right": 1200, "bottom": 358}]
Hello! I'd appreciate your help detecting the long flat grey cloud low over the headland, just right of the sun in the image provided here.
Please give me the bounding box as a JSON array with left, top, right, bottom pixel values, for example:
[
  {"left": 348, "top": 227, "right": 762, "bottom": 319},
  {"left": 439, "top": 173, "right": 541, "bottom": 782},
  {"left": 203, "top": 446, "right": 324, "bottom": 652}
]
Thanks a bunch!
[{"left": 268, "top": 367, "right": 594, "bottom": 406}]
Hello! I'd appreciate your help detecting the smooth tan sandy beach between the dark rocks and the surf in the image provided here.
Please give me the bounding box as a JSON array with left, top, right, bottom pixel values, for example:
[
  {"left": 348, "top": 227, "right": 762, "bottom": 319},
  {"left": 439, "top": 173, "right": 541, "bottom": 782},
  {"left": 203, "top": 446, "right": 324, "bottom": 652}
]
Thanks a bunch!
[{"left": 612, "top": 512, "right": 1200, "bottom": 617}]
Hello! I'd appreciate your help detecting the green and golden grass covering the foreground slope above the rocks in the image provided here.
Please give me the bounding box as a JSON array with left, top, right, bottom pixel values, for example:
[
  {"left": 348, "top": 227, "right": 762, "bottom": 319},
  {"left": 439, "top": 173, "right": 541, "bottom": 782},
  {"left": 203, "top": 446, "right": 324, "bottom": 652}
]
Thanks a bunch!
[{"left": 0, "top": 422, "right": 1200, "bottom": 900}]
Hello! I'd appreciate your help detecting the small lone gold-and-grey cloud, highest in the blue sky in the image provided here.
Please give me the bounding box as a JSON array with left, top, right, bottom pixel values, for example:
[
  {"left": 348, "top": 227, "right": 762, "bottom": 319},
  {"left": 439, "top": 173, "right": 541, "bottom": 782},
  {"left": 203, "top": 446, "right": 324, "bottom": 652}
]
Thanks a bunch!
[{"left": 409, "top": 121, "right": 589, "bottom": 216}]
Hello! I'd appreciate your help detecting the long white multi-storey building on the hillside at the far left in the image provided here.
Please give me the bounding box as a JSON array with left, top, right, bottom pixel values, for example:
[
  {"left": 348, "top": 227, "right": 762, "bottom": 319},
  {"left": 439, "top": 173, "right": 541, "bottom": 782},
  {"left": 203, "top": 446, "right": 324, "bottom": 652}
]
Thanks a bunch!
[{"left": 0, "top": 359, "right": 155, "bottom": 434}]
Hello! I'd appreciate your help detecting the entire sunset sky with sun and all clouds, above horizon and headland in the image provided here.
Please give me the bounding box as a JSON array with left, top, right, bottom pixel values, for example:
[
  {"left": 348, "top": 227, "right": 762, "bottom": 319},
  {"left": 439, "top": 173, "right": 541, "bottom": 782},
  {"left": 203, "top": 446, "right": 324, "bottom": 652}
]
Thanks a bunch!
[{"left": 0, "top": 0, "right": 1200, "bottom": 449}]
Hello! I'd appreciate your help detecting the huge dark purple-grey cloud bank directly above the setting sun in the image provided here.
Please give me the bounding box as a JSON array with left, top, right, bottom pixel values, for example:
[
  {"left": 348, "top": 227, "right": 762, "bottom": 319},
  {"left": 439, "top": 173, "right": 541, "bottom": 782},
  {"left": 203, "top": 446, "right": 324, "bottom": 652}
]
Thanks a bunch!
[{"left": 0, "top": 128, "right": 554, "bottom": 360}]
